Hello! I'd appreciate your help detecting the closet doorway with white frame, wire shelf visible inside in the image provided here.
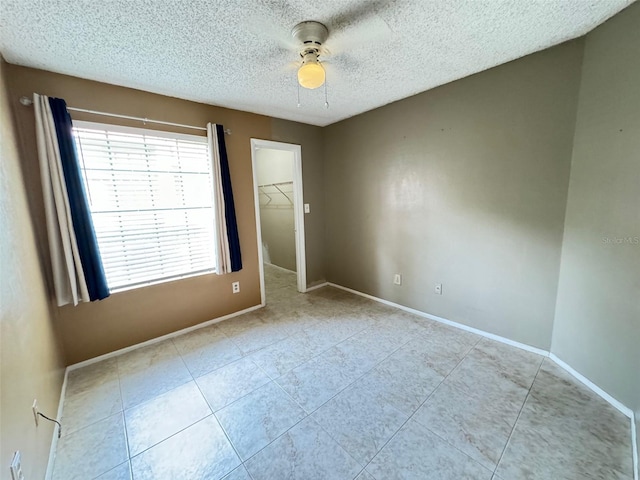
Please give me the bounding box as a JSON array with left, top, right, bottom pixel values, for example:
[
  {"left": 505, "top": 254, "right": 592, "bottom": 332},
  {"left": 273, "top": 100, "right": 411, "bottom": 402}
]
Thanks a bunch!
[{"left": 251, "top": 138, "right": 307, "bottom": 305}]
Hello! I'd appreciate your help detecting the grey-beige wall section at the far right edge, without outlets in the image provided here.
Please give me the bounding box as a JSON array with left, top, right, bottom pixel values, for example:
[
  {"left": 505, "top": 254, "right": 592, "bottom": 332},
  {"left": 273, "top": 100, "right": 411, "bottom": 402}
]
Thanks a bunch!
[{"left": 552, "top": 0, "right": 640, "bottom": 432}]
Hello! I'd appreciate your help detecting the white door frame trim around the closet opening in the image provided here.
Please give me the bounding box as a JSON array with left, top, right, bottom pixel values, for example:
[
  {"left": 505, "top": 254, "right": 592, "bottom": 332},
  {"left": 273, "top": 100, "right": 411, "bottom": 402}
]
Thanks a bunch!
[{"left": 251, "top": 138, "right": 307, "bottom": 306}]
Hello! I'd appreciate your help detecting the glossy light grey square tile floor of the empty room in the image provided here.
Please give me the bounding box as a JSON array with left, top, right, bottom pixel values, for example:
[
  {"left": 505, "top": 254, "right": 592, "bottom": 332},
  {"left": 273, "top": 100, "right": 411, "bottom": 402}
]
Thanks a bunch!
[{"left": 53, "top": 267, "right": 633, "bottom": 480}]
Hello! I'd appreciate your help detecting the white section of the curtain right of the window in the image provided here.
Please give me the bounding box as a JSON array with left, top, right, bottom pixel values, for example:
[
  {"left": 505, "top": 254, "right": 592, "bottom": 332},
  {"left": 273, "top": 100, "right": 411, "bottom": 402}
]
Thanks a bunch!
[{"left": 207, "top": 123, "right": 231, "bottom": 275}]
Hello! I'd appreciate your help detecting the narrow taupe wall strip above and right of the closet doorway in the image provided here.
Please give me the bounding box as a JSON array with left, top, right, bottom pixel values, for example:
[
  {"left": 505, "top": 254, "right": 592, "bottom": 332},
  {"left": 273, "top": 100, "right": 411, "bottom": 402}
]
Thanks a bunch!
[{"left": 271, "top": 118, "right": 326, "bottom": 286}]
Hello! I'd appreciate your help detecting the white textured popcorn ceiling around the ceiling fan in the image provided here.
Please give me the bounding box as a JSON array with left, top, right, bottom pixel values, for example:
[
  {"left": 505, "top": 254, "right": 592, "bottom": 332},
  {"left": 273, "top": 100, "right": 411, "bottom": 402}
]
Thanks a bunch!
[{"left": 0, "top": 0, "right": 633, "bottom": 125}]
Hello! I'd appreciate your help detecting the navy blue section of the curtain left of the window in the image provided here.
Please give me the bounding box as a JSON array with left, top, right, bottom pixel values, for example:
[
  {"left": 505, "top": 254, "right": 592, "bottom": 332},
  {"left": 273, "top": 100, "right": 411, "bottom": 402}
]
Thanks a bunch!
[{"left": 49, "top": 98, "right": 109, "bottom": 302}]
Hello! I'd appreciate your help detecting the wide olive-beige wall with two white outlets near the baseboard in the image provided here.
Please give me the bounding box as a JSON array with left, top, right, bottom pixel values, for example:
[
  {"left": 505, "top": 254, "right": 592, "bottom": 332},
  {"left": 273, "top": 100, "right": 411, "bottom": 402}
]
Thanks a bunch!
[{"left": 324, "top": 41, "right": 582, "bottom": 349}]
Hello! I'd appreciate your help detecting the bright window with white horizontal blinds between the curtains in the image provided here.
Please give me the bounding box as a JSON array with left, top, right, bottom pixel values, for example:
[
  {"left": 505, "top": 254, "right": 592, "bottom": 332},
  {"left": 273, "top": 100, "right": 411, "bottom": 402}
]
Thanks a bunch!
[{"left": 74, "top": 122, "right": 215, "bottom": 290}]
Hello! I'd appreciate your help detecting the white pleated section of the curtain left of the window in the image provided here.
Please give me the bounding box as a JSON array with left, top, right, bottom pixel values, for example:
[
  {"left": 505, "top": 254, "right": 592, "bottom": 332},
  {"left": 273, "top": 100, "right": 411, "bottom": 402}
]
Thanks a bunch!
[{"left": 33, "top": 94, "right": 89, "bottom": 306}]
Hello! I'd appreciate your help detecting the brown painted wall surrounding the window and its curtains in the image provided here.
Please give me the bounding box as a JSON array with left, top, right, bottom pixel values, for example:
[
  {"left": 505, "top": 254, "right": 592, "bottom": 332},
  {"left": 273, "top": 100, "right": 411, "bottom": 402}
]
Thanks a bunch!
[{"left": 7, "top": 65, "right": 270, "bottom": 364}]
